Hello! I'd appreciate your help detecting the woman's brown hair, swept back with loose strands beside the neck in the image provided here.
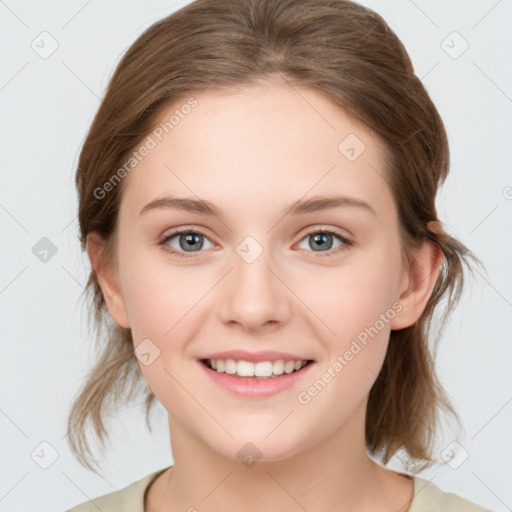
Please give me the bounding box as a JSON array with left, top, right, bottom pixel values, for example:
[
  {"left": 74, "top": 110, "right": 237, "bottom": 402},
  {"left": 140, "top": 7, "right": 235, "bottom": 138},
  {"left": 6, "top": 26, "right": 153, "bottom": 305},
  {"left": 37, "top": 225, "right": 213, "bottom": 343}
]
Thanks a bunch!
[{"left": 68, "top": 0, "right": 480, "bottom": 469}]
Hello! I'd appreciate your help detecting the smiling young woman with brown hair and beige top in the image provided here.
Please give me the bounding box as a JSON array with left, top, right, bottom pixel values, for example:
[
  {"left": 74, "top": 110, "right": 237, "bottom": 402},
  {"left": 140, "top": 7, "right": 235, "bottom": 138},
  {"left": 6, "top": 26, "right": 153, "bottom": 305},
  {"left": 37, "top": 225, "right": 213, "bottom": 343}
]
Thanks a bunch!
[{"left": 64, "top": 0, "right": 492, "bottom": 512}]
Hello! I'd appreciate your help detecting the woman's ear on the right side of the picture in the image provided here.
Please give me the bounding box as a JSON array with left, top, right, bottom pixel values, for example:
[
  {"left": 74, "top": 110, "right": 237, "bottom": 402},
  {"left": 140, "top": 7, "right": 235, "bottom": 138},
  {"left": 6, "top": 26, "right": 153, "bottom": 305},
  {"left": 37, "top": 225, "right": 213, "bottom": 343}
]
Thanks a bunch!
[{"left": 390, "top": 221, "right": 443, "bottom": 330}]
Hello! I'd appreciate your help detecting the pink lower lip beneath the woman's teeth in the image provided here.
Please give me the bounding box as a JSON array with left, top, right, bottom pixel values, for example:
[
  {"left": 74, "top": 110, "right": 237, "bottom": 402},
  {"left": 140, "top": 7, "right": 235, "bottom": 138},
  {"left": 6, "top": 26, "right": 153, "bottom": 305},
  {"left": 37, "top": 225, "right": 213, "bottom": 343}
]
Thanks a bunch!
[{"left": 199, "top": 361, "right": 314, "bottom": 397}]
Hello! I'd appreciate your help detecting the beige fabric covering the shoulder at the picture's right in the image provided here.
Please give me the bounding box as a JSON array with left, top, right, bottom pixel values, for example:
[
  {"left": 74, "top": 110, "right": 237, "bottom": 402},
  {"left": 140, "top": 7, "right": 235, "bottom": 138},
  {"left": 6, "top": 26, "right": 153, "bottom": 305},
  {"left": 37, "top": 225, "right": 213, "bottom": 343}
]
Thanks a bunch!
[{"left": 409, "top": 475, "right": 493, "bottom": 512}]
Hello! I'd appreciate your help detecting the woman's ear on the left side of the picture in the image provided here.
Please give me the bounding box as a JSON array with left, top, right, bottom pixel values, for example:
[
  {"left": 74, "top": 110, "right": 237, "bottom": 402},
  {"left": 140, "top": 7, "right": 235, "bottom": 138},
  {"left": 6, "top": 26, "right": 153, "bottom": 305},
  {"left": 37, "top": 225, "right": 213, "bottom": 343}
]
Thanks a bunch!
[{"left": 87, "top": 232, "right": 130, "bottom": 329}]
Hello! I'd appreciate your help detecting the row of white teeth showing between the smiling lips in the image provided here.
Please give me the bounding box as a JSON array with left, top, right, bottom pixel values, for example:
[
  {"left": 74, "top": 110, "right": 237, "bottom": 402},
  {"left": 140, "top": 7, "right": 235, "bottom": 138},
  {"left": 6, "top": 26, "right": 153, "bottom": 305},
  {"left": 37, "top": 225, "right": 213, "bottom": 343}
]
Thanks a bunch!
[{"left": 200, "top": 359, "right": 314, "bottom": 380}]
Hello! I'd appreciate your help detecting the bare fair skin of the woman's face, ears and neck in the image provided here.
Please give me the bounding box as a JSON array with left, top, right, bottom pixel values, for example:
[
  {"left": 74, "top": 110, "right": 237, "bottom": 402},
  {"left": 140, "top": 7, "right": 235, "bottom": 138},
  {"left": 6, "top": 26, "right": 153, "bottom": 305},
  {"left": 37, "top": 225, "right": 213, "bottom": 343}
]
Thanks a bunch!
[{"left": 88, "top": 77, "right": 441, "bottom": 512}]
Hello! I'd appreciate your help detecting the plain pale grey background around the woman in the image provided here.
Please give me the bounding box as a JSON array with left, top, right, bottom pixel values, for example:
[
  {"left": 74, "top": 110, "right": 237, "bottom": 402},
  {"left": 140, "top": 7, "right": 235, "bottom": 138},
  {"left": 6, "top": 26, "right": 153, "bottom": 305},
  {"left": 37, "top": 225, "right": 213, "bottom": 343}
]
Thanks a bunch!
[{"left": 0, "top": 0, "right": 512, "bottom": 512}]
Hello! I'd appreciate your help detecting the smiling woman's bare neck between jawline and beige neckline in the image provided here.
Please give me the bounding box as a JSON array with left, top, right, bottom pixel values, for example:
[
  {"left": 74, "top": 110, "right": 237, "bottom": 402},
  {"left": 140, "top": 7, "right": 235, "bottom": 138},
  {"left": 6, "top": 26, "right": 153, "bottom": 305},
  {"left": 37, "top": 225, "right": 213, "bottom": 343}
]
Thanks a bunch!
[{"left": 146, "top": 408, "right": 413, "bottom": 512}]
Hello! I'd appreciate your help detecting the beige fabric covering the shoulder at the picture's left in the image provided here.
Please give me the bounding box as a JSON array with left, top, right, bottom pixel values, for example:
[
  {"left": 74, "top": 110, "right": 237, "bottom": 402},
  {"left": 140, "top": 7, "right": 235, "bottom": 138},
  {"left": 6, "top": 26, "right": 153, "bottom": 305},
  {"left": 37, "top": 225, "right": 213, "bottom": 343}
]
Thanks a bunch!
[{"left": 66, "top": 468, "right": 168, "bottom": 512}]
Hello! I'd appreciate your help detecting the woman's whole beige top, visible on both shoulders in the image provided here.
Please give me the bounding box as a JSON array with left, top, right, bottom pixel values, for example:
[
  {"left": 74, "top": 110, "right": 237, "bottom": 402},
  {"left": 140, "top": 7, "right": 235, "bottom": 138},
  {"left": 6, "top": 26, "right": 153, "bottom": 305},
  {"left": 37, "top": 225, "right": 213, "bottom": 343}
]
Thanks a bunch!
[{"left": 66, "top": 466, "right": 492, "bottom": 512}]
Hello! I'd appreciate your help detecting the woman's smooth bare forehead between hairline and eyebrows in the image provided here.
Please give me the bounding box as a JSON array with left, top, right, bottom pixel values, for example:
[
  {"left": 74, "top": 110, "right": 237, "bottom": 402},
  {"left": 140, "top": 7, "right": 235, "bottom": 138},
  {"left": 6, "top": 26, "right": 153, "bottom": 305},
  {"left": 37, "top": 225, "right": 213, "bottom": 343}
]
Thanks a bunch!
[{"left": 122, "top": 83, "right": 393, "bottom": 222}]
